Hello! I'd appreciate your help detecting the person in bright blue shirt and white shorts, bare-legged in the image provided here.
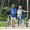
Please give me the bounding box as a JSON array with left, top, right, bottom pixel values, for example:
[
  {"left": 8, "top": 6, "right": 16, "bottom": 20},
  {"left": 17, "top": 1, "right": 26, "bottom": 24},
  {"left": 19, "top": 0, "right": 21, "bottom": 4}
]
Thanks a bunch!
[{"left": 8, "top": 4, "right": 16, "bottom": 27}]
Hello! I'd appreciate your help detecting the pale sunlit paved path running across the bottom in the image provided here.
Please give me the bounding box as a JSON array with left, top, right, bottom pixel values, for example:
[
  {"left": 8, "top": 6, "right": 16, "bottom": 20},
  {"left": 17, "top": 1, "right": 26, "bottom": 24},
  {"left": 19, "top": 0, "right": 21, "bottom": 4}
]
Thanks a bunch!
[{"left": 0, "top": 22, "right": 30, "bottom": 30}]
